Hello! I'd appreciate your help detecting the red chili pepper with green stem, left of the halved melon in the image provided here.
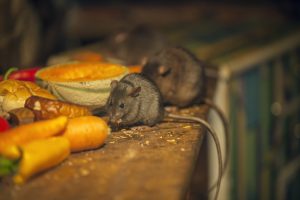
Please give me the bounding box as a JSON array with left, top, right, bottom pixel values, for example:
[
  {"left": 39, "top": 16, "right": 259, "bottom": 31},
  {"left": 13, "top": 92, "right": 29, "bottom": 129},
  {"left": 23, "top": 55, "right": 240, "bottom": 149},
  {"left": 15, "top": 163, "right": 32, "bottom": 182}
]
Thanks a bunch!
[{"left": 4, "top": 67, "right": 40, "bottom": 82}]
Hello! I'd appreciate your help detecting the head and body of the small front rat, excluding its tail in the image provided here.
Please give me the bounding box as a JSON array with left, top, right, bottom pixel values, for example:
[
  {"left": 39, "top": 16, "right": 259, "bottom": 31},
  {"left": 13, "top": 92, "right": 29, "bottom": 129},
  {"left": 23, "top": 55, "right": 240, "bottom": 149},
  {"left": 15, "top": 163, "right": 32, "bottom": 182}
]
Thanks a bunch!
[{"left": 106, "top": 74, "right": 164, "bottom": 126}]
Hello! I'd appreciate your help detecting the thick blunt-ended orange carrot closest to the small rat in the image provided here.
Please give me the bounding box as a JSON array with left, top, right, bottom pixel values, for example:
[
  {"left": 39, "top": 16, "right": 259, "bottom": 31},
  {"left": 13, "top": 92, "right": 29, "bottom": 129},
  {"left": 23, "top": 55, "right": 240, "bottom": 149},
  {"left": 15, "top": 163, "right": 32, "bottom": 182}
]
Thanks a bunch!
[{"left": 63, "top": 116, "right": 110, "bottom": 152}]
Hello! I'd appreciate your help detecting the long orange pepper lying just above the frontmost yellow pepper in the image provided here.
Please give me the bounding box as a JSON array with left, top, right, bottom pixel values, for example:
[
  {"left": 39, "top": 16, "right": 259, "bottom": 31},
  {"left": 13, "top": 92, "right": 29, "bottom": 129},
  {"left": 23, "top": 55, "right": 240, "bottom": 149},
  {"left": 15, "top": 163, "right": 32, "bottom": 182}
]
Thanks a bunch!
[{"left": 0, "top": 116, "right": 68, "bottom": 157}]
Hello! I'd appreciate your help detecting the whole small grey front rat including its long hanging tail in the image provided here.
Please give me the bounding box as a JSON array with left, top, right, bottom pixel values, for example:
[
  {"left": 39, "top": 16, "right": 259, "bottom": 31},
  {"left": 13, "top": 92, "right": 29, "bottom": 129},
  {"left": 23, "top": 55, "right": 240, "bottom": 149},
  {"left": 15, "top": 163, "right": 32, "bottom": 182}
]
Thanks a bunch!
[{"left": 106, "top": 73, "right": 223, "bottom": 198}]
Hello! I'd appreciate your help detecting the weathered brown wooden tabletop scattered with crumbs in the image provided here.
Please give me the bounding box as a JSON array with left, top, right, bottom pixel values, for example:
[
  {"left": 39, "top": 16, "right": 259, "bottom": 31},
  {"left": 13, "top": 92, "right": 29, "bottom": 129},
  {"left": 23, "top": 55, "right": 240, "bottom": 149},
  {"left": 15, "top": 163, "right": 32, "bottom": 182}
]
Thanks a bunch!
[{"left": 0, "top": 106, "right": 207, "bottom": 200}]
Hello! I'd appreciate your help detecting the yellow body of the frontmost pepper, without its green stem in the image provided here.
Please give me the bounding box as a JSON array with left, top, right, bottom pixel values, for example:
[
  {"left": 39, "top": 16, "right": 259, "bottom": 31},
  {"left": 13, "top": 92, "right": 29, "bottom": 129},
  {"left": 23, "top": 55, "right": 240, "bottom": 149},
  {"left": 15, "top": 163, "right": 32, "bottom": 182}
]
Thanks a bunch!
[{"left": 13, "top": 136, "right": 70, "bottom": 184}]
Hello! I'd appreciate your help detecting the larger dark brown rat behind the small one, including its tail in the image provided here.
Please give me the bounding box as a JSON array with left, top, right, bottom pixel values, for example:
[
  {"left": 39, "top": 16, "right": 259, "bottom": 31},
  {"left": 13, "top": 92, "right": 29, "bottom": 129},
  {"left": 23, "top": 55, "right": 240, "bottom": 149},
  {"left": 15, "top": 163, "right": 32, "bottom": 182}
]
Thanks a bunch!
[{"left": 142, "top": 47, "right": 229, "bottom": 180}]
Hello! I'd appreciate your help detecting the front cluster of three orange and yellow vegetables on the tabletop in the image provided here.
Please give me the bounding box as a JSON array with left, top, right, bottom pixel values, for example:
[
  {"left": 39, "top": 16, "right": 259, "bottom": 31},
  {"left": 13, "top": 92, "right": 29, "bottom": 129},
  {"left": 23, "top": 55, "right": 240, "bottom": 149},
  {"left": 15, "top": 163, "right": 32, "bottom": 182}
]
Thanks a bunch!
[{"left": 0, "top": 116, "right": 110, "bottom": 183}]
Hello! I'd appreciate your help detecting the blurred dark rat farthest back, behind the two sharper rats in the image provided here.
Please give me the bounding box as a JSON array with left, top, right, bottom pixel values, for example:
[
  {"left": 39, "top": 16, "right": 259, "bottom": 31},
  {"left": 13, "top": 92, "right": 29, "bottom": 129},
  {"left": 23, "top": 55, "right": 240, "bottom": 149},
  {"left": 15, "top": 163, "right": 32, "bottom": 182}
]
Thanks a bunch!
[{"left": 105, "top": 24, "right": 168, "bottom": 65}]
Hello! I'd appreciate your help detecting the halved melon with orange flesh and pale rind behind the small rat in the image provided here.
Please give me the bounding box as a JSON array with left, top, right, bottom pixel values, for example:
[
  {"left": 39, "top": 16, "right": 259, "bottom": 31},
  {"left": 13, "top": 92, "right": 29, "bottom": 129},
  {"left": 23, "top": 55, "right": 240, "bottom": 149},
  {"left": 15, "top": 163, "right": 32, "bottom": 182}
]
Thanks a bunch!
[{"left": 36, "top": 62, "right": 129, "bottom": 109}]
